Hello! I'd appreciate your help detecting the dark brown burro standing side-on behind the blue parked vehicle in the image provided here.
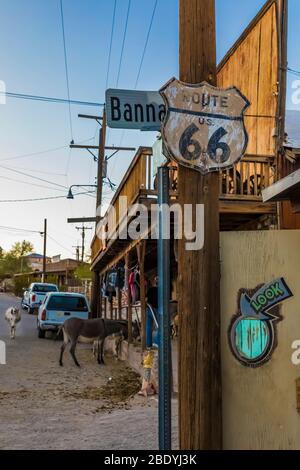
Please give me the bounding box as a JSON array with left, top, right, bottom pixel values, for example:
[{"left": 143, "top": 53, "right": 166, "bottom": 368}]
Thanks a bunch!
[{"left": 59, "top": 318, "right": 137, "bottom": 367}]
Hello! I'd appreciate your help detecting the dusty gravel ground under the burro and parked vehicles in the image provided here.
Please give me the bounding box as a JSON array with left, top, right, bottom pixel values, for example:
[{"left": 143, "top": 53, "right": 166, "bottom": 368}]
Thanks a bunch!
[{"left": 0, "top": 294, "right": 177, "bottom": 450}]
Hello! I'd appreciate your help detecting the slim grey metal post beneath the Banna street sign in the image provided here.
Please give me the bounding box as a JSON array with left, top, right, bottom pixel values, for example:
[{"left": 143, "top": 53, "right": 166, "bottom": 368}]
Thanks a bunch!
[{"left": 158, "top": 167, "right": 172, "bottom": 450}]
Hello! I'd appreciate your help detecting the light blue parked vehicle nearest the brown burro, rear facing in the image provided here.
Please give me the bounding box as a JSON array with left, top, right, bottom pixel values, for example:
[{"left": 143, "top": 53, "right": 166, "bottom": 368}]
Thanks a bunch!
[{"left": 37, "top": 292, "right": 90, "bottom": 338}]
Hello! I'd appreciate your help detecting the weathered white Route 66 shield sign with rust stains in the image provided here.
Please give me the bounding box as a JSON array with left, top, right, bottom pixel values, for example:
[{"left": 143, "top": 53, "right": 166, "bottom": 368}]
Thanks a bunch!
[{"left": 160, "top": 78, "right": 250, "bottom": 174}]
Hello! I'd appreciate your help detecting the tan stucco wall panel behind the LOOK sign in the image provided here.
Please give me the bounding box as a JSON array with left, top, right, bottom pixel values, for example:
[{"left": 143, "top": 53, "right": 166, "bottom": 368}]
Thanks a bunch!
[{"left": 221, "top": 230, "right": 300, "bottom": 449}]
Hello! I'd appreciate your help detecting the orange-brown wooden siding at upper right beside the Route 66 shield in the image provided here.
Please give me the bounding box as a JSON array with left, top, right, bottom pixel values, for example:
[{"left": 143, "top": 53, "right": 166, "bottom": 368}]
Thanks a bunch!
[{"left": 218, "top": 1, "right": 278, "bottom": 156}]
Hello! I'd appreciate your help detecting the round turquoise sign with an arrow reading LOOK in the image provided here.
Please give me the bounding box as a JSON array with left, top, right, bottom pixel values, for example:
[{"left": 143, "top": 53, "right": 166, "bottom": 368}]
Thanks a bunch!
[{"left": 228, "top": 278, "right": 293, "bottom": 367}]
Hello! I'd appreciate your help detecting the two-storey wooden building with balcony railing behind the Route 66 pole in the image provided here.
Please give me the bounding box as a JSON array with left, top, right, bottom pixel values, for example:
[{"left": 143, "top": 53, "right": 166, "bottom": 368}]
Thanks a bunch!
[{"left": 91, "top": 0, "right": 286, "bottom": 348}]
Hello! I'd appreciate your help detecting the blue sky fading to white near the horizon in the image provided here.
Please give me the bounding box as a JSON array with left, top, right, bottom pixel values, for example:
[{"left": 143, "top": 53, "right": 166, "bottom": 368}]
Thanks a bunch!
[{"left": 0, "top": 0, "right": 300, "bottom": 256}]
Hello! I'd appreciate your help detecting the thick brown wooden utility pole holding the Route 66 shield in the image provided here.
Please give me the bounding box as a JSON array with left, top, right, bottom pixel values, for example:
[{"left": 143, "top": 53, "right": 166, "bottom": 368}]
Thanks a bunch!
[{"left": 178, "top": 0, "right": 222, "bottom": 450}]
